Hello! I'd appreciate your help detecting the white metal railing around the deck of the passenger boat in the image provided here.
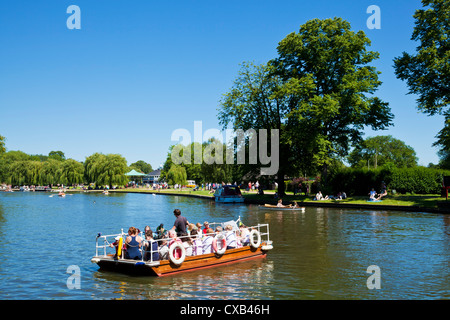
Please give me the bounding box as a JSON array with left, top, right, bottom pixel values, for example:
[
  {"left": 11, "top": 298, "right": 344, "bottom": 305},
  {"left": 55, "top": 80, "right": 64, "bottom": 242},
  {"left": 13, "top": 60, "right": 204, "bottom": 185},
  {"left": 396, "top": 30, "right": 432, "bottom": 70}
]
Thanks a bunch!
[{"left": 95, "top": 218, "right": 271, "bottom": 262}]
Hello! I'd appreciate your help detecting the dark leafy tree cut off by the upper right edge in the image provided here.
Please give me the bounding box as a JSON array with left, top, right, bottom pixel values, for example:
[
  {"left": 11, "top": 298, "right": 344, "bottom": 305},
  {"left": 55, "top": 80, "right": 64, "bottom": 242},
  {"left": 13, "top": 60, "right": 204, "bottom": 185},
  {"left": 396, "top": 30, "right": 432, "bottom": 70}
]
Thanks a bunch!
[{"left": 394, "top": 0, "right": 450, "bottom": 163}]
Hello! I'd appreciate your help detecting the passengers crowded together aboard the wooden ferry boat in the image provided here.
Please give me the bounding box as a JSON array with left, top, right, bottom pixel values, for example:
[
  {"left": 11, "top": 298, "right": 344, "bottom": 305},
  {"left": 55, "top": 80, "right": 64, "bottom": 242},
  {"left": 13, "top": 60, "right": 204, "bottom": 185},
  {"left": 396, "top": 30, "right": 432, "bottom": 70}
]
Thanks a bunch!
[{"left": 110, "top": 209, "right": 250, "bottom": 261}]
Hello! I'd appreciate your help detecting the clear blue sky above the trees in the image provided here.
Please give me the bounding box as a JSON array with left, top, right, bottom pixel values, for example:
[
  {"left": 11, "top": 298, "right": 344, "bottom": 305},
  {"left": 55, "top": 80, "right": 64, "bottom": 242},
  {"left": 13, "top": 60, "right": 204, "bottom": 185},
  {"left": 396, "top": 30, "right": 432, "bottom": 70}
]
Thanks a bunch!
[{"left": 0, "top": 0, "right": 444, "bottom": 168}]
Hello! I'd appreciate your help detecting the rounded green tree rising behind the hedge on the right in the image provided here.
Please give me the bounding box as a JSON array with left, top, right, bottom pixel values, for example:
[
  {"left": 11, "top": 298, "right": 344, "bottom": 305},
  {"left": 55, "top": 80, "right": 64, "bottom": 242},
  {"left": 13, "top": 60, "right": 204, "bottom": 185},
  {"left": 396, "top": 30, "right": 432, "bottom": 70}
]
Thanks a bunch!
[{"left": 348, "top": 136, "right": 417, "bottom": 169}]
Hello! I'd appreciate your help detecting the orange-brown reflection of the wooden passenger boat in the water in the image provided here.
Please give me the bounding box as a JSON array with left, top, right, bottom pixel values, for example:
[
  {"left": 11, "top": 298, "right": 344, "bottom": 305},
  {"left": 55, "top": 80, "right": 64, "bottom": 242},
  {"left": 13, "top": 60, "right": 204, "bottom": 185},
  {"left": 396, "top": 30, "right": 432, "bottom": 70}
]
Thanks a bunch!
[{"left": 93, "top": 258, "right": 274, "bottom": 300}]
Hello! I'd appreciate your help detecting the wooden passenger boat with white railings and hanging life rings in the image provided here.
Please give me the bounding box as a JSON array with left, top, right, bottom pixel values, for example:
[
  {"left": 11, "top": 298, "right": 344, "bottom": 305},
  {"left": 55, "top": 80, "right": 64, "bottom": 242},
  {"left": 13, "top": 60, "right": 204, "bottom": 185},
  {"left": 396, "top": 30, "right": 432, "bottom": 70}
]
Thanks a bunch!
[{"left": 91, "top": 218, "right": 273, "bottom": 276}]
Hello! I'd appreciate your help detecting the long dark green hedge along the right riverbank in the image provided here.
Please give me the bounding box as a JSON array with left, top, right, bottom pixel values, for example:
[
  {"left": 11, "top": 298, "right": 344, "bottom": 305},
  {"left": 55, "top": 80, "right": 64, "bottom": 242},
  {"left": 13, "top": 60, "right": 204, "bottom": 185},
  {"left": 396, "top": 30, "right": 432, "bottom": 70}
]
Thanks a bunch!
[{"left": 329, "top": 167, "right": 450, "bottom": 196}]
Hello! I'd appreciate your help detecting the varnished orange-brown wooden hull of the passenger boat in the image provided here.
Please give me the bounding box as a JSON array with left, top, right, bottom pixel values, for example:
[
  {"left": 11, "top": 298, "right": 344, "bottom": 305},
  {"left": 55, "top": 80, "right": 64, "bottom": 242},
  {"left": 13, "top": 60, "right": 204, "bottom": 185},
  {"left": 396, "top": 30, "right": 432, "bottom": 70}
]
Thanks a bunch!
[{"left": 91, "top": 243, "right": 269, "bottom": 276}]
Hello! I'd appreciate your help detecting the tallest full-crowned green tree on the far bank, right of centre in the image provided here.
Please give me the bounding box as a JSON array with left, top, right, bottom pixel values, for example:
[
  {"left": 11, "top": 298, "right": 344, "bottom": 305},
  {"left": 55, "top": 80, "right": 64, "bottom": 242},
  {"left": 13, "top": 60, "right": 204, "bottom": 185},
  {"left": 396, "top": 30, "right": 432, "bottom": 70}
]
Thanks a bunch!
[{"left": 219, "top": 18, "right": 393, "bottom": 194}]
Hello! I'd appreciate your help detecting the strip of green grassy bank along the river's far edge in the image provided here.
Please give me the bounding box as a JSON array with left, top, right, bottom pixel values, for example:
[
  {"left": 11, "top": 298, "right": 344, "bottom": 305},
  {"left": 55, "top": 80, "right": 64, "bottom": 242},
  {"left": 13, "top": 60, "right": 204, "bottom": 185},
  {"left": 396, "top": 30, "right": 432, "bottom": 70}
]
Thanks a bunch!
[{"left": 110, "top": 189, "right": 450, "bottom": 211}]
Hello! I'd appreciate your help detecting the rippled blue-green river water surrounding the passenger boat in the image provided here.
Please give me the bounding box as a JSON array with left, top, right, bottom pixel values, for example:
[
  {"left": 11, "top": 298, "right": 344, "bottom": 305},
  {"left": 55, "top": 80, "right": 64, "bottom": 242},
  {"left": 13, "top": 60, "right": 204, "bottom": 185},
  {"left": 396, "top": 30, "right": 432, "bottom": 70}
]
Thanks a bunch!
[{"left": 0, "top": 192, "right": 450, "bottom": 300}]
